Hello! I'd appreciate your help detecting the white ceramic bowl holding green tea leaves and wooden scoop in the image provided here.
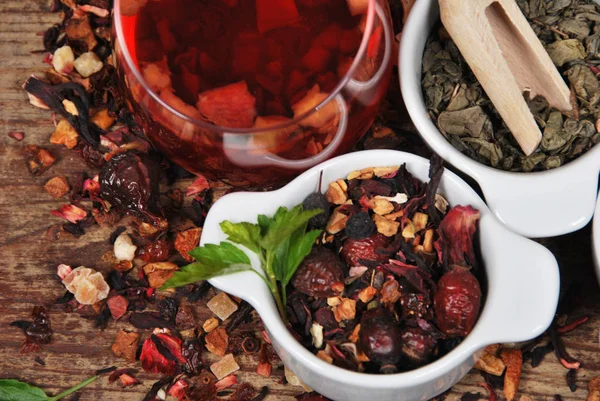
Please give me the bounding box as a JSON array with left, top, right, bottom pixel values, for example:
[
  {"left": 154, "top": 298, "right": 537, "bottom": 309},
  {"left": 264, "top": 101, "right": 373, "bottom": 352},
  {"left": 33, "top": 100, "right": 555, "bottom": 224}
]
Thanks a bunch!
[{"left": 399, "top": 0, "right": 600, "bottom": 238}]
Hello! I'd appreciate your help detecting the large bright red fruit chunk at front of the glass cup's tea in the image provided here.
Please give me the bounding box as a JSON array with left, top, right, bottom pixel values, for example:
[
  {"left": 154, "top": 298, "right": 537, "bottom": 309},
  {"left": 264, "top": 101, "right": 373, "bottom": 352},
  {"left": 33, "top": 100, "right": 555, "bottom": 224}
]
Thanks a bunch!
[{"left": 196, "top": 81, "right": 256, "bottom": 128}]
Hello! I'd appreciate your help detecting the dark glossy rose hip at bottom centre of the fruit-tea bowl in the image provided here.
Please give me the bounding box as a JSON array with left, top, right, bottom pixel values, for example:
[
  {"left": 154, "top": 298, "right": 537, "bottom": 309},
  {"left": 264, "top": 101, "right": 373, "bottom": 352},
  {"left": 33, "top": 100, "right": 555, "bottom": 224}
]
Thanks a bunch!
[{"left": 359, "top": 307, "right": 402, "bottom": 365}]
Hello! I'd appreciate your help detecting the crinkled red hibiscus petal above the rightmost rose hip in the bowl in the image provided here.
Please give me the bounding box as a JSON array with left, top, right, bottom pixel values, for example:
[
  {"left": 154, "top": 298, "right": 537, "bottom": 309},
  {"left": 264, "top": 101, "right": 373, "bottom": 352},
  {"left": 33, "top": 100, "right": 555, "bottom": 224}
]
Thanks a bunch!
[{"left": 436, "top": 205, "right": 480, "bottom": 267}]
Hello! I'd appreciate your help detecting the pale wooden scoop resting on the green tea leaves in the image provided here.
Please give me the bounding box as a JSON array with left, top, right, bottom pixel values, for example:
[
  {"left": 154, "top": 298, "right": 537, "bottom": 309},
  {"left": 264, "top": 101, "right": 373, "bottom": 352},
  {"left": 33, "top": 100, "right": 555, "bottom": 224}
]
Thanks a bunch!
[{"left": 439, "top": 0, "right": 572, "bottom": 155}]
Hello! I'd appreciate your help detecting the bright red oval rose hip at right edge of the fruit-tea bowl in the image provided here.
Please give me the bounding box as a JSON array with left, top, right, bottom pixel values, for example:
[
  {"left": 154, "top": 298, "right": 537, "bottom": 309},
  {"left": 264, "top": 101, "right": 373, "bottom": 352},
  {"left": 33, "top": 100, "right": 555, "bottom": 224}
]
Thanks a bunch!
[{"left": 433, "top": 268, "right": 481, "bottom": 336}]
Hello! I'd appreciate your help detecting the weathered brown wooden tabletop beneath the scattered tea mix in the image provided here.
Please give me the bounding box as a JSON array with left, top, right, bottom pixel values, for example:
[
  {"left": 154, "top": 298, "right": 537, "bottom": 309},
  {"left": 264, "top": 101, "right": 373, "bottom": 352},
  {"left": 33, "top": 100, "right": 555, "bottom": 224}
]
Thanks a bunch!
[{"left": 0, "top": 0, "right": 600, "bottom": 401}]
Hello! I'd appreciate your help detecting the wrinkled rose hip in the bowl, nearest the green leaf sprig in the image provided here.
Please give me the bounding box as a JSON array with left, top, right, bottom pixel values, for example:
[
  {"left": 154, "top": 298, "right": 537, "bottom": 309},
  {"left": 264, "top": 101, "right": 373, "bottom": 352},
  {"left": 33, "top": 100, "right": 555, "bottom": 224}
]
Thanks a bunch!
[{"left": 292, "top": 247, "right": 344, "bottom": 297}]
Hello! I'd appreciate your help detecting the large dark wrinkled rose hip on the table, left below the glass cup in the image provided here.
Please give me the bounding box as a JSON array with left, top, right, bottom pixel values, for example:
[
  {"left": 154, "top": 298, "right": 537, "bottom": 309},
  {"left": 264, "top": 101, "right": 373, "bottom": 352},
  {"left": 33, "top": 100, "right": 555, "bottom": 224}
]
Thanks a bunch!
[{"left": 100, "top": 152, "right": 162, "bottom": 222}]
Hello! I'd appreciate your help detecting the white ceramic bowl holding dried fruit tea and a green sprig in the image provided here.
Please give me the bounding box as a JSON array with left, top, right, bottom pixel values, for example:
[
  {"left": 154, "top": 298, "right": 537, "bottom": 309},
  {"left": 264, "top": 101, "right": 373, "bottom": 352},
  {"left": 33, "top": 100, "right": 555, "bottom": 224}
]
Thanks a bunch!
[{"left": 201, "top": 150, "right": 559, "bottom": 401}]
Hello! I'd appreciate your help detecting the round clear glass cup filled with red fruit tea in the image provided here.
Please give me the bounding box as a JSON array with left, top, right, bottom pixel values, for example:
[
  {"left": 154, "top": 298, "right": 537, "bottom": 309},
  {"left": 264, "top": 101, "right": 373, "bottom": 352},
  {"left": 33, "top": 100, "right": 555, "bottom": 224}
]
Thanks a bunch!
[{"left": 114, "top": 0, "right": 393, "bottom": 186}]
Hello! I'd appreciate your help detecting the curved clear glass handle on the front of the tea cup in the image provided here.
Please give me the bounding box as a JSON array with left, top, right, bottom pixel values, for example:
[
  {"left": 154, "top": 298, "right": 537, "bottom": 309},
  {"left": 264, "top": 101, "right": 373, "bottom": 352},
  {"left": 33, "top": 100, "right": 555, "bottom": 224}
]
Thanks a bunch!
[{"left": 223, "top": 95, "right": 348, "bottom": 170}]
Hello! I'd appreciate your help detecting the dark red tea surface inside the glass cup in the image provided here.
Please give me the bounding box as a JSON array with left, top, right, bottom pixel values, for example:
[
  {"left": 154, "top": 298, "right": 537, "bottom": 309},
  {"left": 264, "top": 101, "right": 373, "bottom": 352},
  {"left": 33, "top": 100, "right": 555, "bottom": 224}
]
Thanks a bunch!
[{"left": 135, "top": 0, "right": 364, "bottom": 117}]
